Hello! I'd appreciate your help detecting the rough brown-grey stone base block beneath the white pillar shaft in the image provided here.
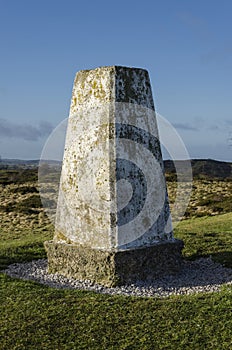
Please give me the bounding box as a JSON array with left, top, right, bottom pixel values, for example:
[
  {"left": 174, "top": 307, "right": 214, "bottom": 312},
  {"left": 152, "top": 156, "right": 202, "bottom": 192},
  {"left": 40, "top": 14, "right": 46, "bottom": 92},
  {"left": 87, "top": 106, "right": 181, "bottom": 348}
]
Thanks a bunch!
[{"left": 44, "top": 239, "right": 184, "bottom": 287}]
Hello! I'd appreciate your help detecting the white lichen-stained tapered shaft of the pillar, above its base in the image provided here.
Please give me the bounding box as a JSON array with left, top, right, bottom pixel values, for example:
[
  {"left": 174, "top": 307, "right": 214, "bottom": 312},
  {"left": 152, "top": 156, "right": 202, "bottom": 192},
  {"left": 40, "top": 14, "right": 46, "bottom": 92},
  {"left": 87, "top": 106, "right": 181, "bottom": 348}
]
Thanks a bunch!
[{"left": 54, "top": 67, "right": 173, "bottom": 250}]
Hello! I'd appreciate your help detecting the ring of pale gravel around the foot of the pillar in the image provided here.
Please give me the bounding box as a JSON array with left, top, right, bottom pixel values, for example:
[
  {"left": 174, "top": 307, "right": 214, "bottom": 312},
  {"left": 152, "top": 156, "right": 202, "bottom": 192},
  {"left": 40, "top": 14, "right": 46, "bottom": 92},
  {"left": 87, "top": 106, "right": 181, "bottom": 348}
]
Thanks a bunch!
[{"left": 2, "top": 258, "right": 232, "bottom": 297}]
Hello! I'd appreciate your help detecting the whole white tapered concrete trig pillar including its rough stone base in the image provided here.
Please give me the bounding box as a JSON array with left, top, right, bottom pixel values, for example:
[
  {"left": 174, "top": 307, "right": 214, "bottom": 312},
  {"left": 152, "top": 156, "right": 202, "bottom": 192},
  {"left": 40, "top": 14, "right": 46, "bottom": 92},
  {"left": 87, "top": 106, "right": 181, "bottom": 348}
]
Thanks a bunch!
[{"left": 45, "top": 66, "right": 183, "bottom": 286}]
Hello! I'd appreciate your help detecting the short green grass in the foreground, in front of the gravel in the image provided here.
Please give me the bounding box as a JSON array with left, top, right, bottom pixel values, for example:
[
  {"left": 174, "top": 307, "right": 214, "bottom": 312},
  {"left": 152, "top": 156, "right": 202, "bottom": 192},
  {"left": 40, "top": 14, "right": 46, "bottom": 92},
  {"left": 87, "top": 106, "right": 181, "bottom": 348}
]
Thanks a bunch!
[{"left": 0, "top": 276, "right": 232, "bottom": 350}]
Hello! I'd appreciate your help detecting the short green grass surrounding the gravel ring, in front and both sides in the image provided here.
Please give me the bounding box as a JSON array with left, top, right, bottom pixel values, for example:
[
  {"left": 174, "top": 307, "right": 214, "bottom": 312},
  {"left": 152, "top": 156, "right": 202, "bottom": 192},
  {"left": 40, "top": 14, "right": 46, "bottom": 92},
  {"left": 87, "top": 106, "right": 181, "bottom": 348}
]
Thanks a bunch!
[{"left": 0, "top": 213, "right": 232, "bottom": 350}]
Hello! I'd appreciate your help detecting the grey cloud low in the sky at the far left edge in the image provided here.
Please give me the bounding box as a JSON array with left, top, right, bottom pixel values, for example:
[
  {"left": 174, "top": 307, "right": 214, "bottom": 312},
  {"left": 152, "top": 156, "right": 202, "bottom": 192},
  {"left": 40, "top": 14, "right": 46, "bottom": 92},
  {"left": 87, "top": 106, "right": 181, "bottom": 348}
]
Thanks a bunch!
[{"left": 0, "top": 118, "right": 52, "bottom": 141}]
